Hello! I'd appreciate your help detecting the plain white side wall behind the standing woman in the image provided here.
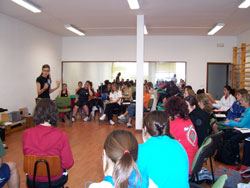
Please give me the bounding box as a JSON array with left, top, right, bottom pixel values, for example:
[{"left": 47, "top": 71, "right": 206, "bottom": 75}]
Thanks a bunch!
[{"left": 0, "top": 14, "right": 61, "bottom": 112}]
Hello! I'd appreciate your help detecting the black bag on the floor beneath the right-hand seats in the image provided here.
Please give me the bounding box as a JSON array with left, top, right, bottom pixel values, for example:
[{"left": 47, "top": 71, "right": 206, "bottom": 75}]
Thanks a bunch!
[{"left": 214, "top": 140, "right": 236, "bottom": 165}]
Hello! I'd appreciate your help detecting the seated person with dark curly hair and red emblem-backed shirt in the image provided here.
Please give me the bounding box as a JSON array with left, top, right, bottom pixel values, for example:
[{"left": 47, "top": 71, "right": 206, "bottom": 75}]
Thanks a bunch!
[{"left": 165, "top": 96, "right": 198, "bottom": 174}]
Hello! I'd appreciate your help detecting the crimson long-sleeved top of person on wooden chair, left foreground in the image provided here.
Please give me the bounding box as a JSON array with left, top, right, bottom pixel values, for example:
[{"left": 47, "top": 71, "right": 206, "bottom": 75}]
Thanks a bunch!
[{"left": 23, "top": 125, "right": 74, "bottom": 182}]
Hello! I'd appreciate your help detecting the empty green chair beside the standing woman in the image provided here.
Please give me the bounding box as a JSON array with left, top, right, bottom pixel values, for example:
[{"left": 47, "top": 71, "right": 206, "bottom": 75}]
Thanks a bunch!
[{"left": 55, "top": 97, "right": 72, "bottom": 126}]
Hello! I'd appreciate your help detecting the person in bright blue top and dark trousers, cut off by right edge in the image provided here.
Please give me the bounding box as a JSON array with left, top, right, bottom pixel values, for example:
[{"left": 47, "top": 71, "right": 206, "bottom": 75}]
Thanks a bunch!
[{"left": 226, "top": 94, "right": 250, "bottom": 164}]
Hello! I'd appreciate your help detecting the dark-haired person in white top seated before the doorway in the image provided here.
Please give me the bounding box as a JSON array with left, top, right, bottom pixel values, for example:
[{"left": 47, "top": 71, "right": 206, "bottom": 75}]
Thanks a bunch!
[{"left": 213, "top": 85, "right": 236, "bottom": 111}]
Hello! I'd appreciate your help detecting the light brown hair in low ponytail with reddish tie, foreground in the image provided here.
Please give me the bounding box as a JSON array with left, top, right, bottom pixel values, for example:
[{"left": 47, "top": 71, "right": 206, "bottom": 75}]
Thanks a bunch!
[{"left": 104, "top": 130, "right": 141, "bottom": 188}]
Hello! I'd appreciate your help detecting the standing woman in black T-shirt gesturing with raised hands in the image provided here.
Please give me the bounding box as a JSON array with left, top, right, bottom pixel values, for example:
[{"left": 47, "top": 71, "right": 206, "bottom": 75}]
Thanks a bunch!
[{"left": 36, "top": 64, "right": 60, "bottom": 99}]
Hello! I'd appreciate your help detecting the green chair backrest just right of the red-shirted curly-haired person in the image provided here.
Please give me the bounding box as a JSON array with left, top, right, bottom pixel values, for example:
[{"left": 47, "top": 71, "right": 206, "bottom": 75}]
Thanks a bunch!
[{"left": 191, "top": 138, "right": 213, "bottom": 174}]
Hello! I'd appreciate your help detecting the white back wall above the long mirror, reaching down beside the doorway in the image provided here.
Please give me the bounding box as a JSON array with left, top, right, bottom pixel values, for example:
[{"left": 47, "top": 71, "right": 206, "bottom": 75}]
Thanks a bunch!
[{"left": 62, "top": 36, "right": 237, "bottom": 90}]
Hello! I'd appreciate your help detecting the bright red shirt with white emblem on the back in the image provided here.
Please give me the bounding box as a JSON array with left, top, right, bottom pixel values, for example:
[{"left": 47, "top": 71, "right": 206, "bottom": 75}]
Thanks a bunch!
[{"left": 170, "top": 118, "right": 198, "bottom": 174}]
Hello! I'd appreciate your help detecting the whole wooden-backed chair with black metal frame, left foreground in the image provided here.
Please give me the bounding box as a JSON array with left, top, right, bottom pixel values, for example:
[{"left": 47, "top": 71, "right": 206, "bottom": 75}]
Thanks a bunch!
[{"left": 24, "top": 155, "right": 67, "bottom": 188}]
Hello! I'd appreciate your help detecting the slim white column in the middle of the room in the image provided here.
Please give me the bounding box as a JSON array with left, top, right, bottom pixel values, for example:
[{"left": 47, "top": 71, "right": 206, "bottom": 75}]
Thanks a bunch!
[{"left": 135, "top": 15, "right": 144, "bottom": 130}]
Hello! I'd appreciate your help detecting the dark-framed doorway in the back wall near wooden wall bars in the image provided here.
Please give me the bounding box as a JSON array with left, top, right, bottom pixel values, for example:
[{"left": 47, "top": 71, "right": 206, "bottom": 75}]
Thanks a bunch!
[{"left": 207, "top": 63, "right": 232, "bottom": 100}]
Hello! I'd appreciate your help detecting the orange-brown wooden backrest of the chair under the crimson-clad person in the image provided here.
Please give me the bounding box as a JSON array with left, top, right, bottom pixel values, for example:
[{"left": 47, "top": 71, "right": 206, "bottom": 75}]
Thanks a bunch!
[{"left": 23, "top": 155, "right": 61, "bottom": 176}]
